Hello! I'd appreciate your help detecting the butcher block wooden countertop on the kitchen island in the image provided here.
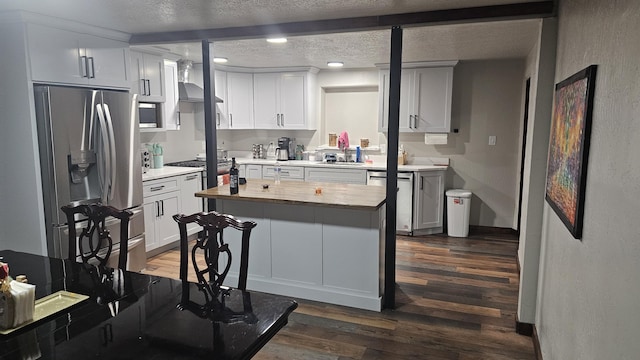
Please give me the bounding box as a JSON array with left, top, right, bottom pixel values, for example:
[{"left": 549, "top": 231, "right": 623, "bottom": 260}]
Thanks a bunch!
[{"left": 195, "top": 179, "right": 386, "bottom": 210}]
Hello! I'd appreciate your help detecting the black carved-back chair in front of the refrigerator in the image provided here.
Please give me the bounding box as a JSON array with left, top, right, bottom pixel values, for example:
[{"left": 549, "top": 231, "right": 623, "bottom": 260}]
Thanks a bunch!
[{"left": 61, "top": 204, "right": 133, "bottom": 270}]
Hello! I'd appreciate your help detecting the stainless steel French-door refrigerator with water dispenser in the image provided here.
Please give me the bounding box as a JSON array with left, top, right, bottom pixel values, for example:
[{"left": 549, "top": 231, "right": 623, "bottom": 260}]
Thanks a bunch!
[{"left": 34, "top": 85, "right": 146, "bottom": 271}]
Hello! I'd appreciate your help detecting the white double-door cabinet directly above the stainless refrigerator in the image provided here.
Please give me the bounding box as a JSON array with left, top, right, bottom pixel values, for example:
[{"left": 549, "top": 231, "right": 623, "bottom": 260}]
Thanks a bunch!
[{"left": 27, "top": 24, "right": 131, "bottom": 89}]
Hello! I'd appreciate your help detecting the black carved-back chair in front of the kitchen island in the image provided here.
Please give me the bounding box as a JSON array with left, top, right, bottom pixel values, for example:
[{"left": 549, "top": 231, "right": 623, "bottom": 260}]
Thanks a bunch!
[{"left": 173, "top": 211, "right": 256, "bottom": 316}]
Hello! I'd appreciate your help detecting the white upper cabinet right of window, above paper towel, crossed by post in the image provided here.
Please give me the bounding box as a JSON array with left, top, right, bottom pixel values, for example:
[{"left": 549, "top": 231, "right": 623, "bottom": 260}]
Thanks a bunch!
[{"left": 379, "top": 65, "right": 453, "bottom": 133}]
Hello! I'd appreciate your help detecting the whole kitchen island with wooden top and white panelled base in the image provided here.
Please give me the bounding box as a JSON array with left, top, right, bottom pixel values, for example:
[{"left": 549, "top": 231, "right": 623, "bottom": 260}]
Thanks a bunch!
[{"left": 196, "top": 179, "right": 386, "bottom": 311}]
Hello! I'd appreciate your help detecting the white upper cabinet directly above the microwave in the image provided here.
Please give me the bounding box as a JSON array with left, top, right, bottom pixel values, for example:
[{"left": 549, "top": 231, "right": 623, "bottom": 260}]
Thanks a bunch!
[{"left": 131, "top": 50, "right": 166, "bottom": 102}]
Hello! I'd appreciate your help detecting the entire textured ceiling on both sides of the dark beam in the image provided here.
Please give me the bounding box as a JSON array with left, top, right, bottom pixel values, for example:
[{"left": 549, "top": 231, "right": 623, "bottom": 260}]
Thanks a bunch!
[{"left": 0, "top": 0, "right": 539, "bottom": 69}]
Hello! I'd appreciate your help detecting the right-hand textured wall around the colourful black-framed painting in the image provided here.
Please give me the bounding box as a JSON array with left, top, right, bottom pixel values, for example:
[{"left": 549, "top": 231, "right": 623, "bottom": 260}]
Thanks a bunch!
[{"left": 536, "top": 0, "right": 640, "bottom": 359}]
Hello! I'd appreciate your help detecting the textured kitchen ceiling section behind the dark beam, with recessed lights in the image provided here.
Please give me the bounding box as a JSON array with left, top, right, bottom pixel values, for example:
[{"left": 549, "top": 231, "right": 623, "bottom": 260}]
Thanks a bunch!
[{"left": 151, "top": 20, "right": 539, "bottom": 69}]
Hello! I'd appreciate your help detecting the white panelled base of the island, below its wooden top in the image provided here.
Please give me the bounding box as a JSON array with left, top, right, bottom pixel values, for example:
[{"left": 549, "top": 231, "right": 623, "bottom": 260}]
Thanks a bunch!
[{"left": 216, "top": 198, "right": 385, "bottom": 311}]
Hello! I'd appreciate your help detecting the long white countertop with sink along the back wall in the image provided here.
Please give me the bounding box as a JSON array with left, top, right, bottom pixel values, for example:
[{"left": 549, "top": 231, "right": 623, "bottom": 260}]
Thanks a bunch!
[{"left": 236, "top": 158, "right": 448, "bottom": 172}]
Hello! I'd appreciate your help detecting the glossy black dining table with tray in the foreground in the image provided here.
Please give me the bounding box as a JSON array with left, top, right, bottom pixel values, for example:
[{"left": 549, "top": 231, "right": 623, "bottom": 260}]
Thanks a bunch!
[{"left": 0, "top": 250, "right": 297, "bottom": 360}]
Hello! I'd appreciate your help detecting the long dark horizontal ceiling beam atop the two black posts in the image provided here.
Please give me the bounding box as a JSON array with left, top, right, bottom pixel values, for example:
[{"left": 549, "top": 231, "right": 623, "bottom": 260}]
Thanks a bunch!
[{"left": 129, "top": 1, "right": 555, "bottom": 44}]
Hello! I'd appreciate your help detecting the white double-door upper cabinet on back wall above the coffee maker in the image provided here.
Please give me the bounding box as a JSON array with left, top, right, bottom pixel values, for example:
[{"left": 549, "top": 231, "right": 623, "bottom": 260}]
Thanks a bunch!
[{"left": 253, "top": 72, "right": 308, "bottom": 129}]
